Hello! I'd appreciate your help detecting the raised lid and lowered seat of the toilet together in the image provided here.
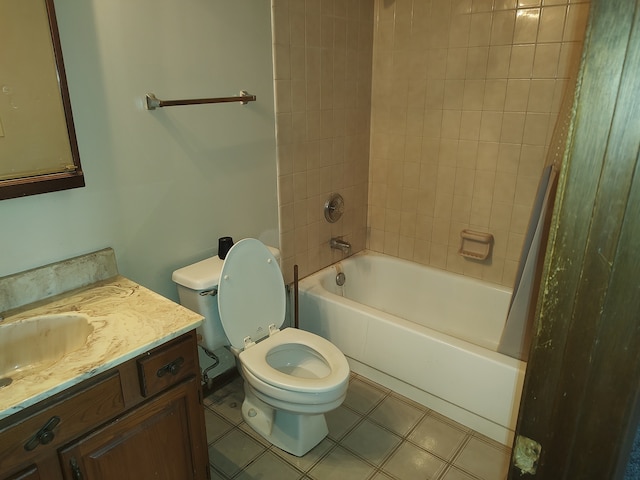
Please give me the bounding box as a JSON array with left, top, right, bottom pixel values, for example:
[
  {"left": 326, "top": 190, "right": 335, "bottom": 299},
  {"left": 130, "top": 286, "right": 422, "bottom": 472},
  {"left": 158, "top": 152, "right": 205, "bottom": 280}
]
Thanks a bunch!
[{"left": 218, "top": 238, "right": 349, "bottom": 403}]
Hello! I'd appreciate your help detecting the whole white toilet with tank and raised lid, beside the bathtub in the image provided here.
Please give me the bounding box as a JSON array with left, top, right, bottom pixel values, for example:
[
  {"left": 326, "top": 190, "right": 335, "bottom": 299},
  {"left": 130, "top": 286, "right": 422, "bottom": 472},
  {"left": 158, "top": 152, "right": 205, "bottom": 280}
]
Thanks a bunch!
[{"left": 173, "top": 238, "right": 349, "bottom": 456}]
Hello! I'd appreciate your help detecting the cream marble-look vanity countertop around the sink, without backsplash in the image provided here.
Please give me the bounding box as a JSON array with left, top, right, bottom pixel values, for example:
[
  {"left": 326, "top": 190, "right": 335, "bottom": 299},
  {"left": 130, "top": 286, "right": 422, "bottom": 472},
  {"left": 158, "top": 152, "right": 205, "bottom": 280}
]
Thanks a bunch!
[{"left": 0, "top": 275, "right": 203, "bottom": 419}]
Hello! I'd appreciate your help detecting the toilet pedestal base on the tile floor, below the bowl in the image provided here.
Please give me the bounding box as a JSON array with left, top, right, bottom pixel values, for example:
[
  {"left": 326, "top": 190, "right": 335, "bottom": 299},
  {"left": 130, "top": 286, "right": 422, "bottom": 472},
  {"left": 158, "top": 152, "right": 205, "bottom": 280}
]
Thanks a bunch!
[{"left": 242, "top": 381, "right": 329, "bottom": 457}]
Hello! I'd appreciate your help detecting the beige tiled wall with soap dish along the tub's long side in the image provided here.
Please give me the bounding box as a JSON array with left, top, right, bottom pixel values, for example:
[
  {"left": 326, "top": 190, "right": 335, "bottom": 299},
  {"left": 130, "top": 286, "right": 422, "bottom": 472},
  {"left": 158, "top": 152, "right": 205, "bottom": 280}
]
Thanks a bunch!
[{"left": 368, "top": 0, "right": 589, "bottom": 286}]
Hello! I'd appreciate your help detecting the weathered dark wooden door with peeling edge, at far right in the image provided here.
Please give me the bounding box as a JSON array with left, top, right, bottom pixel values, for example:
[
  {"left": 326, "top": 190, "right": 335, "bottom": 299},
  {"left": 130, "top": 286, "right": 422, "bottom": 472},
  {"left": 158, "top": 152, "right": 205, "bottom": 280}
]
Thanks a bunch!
[{"left": 509, "top": 0, "right": 640, "bottom": 480}]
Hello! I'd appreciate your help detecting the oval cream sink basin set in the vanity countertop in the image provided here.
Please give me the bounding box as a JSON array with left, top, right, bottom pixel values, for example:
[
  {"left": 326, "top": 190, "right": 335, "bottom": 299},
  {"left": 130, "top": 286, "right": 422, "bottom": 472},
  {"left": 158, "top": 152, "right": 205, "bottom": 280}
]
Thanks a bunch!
[{"left": 0, "top": 313, "right": 93, "bottom": 384}]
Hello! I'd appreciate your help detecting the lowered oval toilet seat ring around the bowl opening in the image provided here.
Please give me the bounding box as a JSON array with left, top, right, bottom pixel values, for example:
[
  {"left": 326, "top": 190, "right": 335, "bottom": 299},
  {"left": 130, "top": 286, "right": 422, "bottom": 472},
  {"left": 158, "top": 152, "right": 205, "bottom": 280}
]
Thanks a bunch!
[{"left": 240, "top": 328, "right": 349, "bottom": 394}]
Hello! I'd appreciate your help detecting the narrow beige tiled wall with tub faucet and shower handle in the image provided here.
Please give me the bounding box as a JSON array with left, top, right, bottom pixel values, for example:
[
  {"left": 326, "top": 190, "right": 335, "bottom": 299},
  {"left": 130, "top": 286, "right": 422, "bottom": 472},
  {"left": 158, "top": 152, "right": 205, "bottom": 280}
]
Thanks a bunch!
[{"left": 272, "top": 0, "right": 374, "bottom": 282}]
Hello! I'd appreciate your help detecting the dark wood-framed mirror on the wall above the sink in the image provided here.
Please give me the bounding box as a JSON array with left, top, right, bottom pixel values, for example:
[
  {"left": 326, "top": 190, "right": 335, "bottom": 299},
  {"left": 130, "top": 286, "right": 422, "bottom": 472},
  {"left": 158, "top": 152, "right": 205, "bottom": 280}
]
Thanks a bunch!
[{"left": 0, "top": 0, "right": 84, "bottom": 200}]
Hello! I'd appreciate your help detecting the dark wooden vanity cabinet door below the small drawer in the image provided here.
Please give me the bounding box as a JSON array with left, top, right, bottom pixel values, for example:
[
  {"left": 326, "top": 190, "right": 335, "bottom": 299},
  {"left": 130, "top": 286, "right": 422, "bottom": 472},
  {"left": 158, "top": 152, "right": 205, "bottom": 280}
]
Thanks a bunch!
[{"left": 60, "top": 377, "right": 207, "bottom": 480}]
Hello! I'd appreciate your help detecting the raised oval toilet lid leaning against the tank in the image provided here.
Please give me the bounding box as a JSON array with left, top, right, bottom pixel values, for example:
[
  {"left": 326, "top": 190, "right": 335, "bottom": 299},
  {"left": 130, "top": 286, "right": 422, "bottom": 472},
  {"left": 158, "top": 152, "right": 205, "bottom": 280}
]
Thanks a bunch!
[{"left": 218, "top": 238, "right": 286, "bottom": 349}]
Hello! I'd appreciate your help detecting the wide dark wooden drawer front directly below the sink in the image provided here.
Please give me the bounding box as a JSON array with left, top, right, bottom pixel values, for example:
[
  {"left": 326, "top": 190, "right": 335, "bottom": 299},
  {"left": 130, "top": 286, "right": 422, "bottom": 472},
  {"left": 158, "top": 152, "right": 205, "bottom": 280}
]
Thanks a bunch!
[{"left": 0, "top": 371, "right": 124, "bottom": 472}]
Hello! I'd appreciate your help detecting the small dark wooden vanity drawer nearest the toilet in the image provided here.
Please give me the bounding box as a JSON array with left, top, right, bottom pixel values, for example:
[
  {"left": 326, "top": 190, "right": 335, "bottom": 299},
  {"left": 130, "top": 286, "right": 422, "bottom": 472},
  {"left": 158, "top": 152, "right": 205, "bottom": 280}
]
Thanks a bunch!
[{"left": 138, "top": 336, "right": 198, "bottom": 397}]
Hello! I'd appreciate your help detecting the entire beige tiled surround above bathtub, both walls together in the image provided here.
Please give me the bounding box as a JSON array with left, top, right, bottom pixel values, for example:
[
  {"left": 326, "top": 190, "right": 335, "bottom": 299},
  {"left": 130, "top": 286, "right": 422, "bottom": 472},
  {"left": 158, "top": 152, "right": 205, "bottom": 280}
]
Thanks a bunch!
[{"left": 272, "top": 0, "right": 589, "bottom": 286}]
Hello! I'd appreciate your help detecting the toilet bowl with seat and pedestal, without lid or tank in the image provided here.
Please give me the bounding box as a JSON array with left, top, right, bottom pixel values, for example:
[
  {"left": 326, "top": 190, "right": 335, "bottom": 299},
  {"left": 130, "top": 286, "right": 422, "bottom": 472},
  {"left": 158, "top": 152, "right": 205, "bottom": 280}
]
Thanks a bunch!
[{"left": 239, "top": 328, "right": 349, "bottom": 456}]
